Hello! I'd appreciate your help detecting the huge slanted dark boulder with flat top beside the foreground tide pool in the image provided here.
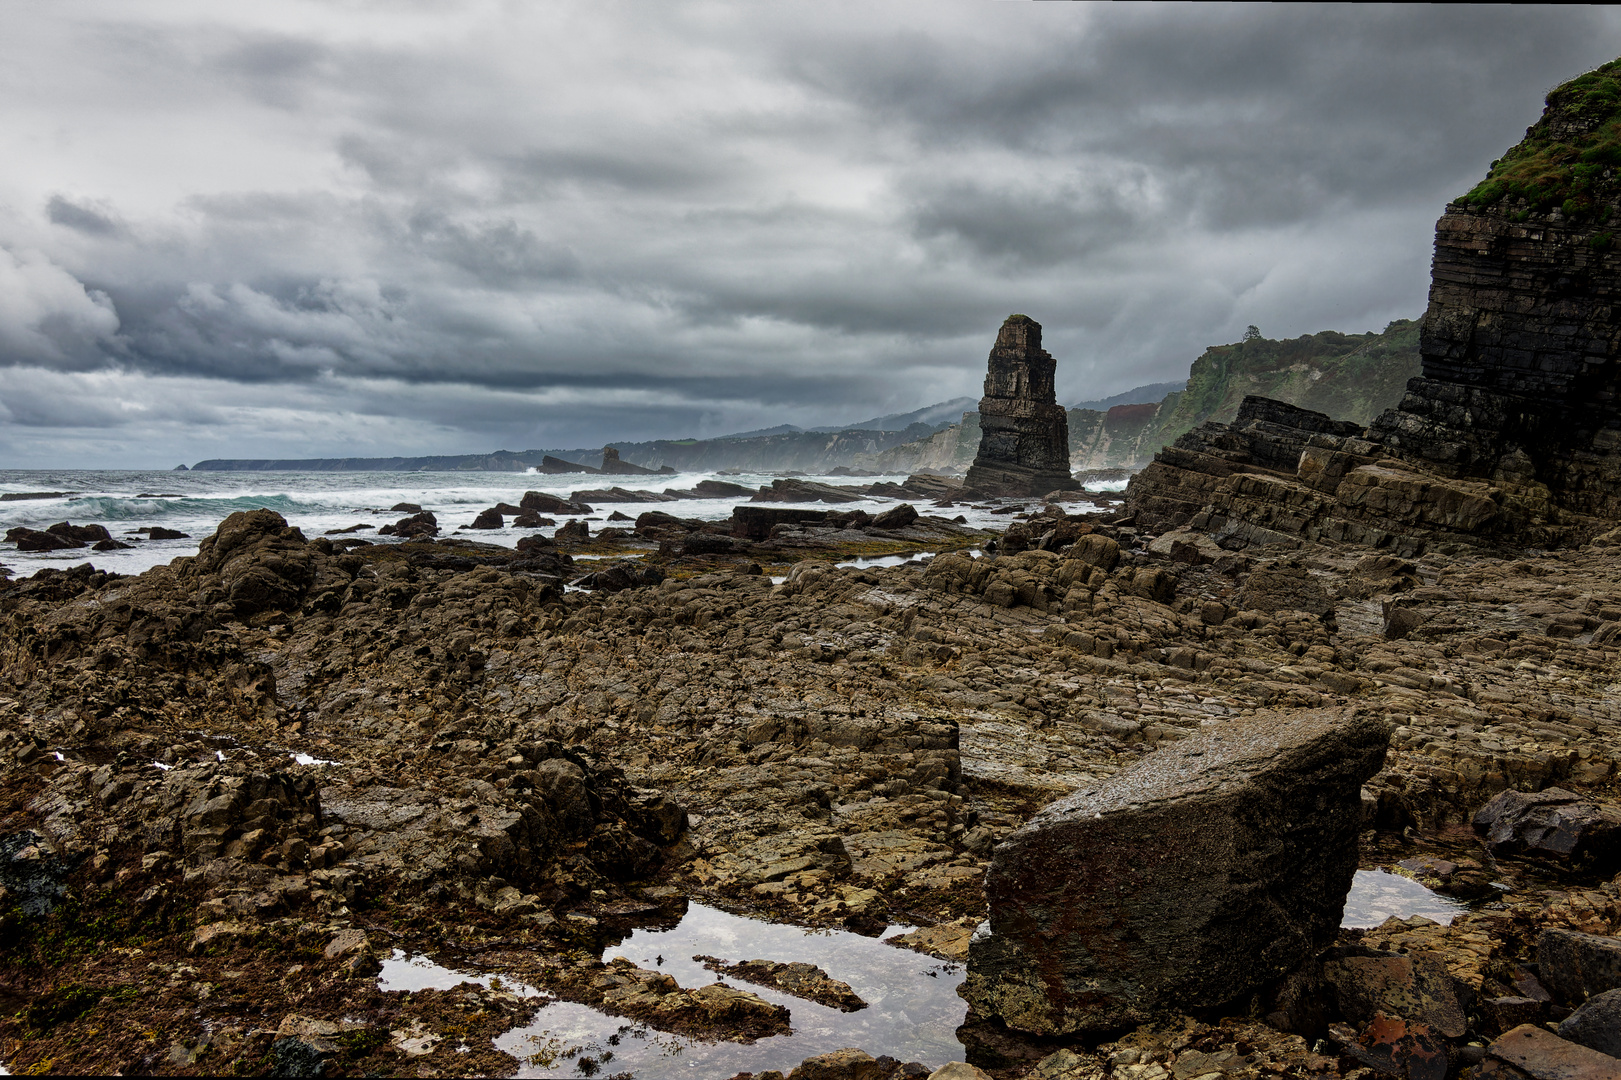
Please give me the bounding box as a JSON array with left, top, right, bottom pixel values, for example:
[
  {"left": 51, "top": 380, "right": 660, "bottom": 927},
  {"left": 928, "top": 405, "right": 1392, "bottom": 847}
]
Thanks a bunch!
[{"left": 960, "top": 709, "right": 1391, "bottom": 1035}]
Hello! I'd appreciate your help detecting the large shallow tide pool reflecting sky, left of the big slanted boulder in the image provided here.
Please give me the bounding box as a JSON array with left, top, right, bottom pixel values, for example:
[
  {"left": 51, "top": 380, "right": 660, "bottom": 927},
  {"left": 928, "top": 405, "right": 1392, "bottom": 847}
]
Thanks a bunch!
[{"left": 496, "top": 903, "right": 968, "bottom": 1080}]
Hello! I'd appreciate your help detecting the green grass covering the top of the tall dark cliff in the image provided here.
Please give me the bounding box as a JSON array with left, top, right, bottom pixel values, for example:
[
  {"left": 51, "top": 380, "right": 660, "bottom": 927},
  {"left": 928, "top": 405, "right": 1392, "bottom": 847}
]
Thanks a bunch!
[{"left": 1457, "top": 60, "right": 1621, "bottom": 221}]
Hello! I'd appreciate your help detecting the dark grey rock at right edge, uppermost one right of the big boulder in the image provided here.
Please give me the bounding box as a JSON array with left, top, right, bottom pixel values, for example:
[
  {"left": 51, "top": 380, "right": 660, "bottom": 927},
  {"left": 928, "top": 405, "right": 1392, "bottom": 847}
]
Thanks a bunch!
[{"left": 1473, "top": 788, "right": 1621, "bottom": 874}]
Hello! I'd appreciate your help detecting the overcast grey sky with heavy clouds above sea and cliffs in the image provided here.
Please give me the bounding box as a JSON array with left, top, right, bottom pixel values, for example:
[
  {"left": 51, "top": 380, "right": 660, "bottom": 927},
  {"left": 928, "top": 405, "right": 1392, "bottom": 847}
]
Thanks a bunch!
[{"left": 0, "top": 0, "right": 1621, "bottom": 467}]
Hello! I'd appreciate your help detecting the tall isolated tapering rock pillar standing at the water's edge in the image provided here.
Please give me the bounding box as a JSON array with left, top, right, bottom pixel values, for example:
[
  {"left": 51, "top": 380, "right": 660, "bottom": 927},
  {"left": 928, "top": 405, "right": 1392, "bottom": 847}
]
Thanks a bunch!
[{"left": 964, "top": 315, "right": 1075, "bottom": 496}]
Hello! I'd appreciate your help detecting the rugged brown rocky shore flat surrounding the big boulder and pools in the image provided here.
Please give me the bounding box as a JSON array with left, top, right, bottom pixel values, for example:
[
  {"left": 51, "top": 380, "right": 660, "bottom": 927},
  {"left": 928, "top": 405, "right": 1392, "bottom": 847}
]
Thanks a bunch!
[{"left": 0, "top": 489, "right": 1621, "bottom": 1077}]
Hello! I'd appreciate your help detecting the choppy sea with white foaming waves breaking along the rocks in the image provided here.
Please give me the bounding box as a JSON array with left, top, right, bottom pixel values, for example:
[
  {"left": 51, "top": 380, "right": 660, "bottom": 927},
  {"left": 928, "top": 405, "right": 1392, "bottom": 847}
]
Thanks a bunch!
[{"left": 0, "top": 469, "right": 1123, "bottom": 577}]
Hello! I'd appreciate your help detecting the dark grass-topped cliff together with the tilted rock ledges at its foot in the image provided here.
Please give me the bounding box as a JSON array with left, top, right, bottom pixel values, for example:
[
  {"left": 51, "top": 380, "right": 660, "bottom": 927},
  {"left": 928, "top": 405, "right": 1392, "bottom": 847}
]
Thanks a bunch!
[{"left": 1128, "top": 65, "right": 1621, "bottom": 553}]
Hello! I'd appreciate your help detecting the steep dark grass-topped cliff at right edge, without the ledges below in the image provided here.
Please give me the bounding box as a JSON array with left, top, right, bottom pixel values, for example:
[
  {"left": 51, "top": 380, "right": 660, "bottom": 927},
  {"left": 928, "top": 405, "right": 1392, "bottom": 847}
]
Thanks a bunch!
[{"left": 1371, "top": 62, "right": 1621, "bottom": 517}]
